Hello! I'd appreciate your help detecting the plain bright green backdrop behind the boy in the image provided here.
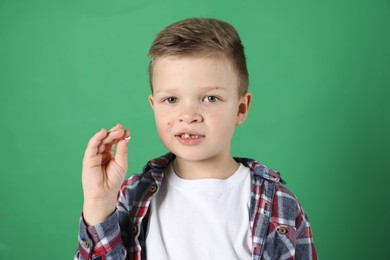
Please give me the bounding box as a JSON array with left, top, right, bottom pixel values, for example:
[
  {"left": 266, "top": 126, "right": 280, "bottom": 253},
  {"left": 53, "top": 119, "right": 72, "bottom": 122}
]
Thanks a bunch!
[{"left": 0, "top": 0, "right": 390, "bottom": 260}]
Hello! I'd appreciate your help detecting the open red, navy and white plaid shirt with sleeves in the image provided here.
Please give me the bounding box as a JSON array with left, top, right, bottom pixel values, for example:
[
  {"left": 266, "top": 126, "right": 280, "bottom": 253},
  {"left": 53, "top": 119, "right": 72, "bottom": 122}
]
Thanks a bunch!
[{"left": 75, "top": 153, "right": 318, "bottom": 260}]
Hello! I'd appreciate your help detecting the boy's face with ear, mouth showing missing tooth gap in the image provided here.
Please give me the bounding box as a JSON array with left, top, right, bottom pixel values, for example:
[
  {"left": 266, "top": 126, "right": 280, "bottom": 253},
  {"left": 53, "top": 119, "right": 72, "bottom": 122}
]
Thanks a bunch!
[{"left": 149, "top": 56, "right": 251, "bottom": 164}]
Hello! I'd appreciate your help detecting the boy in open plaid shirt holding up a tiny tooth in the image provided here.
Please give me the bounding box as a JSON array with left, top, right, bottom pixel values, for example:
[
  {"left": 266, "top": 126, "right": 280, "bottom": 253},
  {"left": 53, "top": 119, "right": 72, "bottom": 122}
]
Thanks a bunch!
[{"left": 75, "top": 18, "right": 317, "bottom": 260}]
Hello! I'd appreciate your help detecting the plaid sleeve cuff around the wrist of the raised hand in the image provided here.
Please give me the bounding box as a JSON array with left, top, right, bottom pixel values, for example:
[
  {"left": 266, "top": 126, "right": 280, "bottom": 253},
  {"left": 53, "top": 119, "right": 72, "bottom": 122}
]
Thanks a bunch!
[{"left": 74, "top": 212, "right": 126, "bottom": 260}]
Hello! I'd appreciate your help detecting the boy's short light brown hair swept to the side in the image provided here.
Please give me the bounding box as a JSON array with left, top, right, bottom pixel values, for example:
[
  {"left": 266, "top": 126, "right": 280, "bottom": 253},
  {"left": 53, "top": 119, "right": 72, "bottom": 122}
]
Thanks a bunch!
[{"left": 149, "top": 18, "right": 249, "bottom": 95}]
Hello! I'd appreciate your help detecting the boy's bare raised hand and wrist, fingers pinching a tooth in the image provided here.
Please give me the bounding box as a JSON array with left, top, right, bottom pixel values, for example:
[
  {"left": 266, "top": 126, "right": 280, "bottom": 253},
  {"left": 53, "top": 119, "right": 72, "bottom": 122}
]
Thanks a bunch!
[{"left": 82, "top": 124, "right": 130, "bottom": 225}]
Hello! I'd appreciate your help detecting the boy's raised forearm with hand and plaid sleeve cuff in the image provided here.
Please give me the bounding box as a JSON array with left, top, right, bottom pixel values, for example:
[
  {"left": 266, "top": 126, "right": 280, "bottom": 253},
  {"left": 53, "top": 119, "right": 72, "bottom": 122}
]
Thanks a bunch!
[{"left": 75, "top": 124, "right": 130, "bottom": 259}]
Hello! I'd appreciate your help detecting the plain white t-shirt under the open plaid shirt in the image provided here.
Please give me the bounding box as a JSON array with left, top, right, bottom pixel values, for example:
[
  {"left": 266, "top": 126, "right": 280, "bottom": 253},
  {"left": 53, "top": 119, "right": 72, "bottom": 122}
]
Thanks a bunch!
[{"left": 146, "top": 161, "right": 252, "bottom": 260}]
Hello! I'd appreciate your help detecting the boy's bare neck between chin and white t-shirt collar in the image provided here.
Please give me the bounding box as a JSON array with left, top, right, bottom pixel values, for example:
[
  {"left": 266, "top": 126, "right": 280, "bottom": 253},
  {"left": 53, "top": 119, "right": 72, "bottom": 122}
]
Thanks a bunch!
[{"left": 172, "top": 155, "right": 239, "bottom": 180}]
